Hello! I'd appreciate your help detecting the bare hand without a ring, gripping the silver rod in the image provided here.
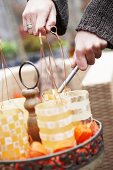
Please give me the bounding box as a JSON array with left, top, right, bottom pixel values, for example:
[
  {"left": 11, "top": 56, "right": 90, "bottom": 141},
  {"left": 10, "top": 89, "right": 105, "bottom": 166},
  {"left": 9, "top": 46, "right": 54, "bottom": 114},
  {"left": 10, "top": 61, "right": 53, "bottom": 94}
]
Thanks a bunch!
[{"left": 72, "top": 31, "right": 107, "bottom": 70}]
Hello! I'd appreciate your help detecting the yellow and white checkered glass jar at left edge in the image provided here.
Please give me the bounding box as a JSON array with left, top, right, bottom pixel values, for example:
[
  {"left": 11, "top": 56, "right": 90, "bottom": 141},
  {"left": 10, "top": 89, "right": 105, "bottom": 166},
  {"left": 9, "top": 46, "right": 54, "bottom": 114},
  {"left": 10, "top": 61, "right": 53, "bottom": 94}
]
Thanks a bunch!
[{"left": 0, "top": 101, "right": 29, "bottom": 160}]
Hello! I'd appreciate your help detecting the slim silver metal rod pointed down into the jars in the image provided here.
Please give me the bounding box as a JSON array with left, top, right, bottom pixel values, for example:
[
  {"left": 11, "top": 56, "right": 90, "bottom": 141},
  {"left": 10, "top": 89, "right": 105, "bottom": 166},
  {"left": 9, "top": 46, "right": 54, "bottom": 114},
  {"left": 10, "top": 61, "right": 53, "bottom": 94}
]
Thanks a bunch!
[{"left": 58, "top": 66, "right": 79, "bottom": 93}]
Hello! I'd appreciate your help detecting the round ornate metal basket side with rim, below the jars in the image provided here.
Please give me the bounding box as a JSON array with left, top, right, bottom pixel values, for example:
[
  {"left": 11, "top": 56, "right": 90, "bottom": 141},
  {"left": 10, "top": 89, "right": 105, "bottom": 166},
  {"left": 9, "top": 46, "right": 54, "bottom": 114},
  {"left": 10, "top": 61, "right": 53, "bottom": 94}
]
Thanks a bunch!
[{"left": 0, "top": 120, "right": 104, "bottom": 170}]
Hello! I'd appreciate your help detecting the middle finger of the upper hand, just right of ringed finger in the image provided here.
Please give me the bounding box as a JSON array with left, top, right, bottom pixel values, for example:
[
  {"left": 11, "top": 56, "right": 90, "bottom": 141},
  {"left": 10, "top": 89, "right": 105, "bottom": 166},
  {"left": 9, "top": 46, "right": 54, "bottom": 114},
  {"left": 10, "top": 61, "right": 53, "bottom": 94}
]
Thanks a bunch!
[{"left": 35, "top": 14, "right": 47, "bottom": 35}]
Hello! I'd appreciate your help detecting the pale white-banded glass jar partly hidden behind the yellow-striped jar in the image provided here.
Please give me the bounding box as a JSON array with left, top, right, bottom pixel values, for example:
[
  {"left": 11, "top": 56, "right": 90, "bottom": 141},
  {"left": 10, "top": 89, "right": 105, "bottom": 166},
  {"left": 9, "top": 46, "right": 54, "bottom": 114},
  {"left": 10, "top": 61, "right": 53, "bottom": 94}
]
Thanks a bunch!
[{"left": 60, "top": 90, "right": 92, "bottom": 125}]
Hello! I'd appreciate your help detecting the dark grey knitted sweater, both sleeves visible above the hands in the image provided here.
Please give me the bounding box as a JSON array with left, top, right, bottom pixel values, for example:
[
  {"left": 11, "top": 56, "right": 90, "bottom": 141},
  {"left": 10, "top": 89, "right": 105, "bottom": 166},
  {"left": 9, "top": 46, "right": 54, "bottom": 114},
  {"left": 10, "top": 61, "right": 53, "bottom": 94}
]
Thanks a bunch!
[{"left": 26, "top": 0, "right": 113, "bottom": 48}]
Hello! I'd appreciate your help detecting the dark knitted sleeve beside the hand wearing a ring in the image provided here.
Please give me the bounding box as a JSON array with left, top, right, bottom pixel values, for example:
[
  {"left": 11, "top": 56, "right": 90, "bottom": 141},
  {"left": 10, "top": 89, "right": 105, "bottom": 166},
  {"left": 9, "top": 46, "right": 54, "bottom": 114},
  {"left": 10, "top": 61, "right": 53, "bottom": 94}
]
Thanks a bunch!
[{"left": 53, "top": 0, "right": 69, "bottom": 35}]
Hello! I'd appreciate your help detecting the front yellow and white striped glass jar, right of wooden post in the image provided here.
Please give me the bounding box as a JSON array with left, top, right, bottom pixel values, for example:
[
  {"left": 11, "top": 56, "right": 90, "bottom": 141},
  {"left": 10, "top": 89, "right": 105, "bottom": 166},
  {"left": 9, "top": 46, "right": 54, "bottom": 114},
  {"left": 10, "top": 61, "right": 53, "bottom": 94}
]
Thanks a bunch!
[{"left": 36, "top": 100, "right": 75, "bottom": 152}]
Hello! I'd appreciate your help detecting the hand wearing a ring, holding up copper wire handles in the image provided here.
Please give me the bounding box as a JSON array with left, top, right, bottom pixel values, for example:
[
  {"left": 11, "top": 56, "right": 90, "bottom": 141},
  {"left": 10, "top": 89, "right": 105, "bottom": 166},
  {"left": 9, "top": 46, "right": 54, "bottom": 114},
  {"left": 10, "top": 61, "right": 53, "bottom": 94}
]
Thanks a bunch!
[{"left": 22, "top": 0, "right": 56, "bottom": 35}]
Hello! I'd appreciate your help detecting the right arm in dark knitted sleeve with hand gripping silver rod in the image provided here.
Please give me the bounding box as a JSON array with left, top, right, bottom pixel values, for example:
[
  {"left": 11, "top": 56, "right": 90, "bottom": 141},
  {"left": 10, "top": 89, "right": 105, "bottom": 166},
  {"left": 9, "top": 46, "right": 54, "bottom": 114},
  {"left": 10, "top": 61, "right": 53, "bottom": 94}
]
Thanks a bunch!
[{"left": 73, "top": 0, "right": 113, "bottom": 70}]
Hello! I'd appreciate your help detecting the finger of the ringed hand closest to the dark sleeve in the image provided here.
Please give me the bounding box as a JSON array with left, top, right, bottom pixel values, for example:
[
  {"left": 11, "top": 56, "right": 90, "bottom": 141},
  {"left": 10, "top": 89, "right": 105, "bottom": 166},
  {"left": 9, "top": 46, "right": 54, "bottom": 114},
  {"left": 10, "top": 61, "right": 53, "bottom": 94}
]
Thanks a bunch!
[{"left": 46, "top": 6, "right": 56, "bottom": 32}]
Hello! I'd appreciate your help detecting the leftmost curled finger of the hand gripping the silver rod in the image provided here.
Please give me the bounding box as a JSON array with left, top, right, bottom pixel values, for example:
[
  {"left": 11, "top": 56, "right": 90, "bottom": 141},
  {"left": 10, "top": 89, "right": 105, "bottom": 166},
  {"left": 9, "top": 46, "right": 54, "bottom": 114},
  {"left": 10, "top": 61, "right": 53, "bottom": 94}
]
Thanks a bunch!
[{"left": 75, "top": 50, "right": 88, "bottom": 70}]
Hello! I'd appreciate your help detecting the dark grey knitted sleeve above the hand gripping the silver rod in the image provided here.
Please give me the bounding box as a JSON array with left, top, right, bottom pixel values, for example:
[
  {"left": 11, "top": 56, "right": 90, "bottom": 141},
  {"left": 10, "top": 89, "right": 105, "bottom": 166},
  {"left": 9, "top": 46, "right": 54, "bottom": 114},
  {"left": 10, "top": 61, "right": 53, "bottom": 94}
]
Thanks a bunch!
[{"left": 76, "top": 0, "right": 113, "bottom": 48}]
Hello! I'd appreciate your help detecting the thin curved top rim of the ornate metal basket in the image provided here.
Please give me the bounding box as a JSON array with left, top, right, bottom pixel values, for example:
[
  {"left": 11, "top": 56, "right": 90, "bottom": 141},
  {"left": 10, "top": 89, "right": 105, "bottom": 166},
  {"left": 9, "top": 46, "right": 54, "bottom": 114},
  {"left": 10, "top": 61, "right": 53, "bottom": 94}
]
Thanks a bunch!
[{"left": 0, "top": 119, "right": 102, "bottom": 164}]
